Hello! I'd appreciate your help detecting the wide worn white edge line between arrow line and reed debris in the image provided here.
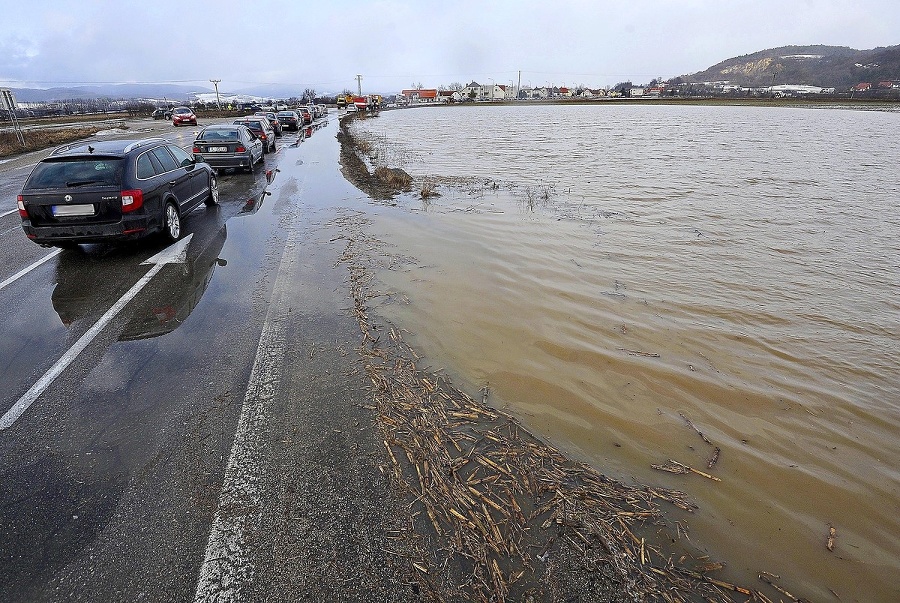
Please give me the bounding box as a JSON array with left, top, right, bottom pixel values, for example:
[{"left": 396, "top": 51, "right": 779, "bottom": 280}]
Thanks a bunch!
[{"left": 194, "top": 230, "right": 296, "bottom": 603}]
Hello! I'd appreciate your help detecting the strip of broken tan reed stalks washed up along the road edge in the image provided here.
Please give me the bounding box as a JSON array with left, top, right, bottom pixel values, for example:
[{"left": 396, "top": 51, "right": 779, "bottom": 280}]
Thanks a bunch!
[{"left": 326, "top": 199, "right": 800, "bottom": 603}]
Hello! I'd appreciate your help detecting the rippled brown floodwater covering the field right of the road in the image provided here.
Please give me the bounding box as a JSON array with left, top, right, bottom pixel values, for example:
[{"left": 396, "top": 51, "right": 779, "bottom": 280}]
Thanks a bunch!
[{"left": 353, "top": 105, "right": 900, "bottom": 601}]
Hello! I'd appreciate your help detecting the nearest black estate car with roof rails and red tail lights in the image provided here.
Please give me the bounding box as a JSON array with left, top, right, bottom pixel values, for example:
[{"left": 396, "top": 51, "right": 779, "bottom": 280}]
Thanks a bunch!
[{"left": 17, "top": 138, "right": 219, "bottom": 247}]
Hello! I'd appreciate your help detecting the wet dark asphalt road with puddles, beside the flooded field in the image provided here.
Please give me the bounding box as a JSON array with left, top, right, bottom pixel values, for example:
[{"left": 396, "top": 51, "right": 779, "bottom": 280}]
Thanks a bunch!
[{"left": 0, "top": 116, "right": 409, "bottom": 602}]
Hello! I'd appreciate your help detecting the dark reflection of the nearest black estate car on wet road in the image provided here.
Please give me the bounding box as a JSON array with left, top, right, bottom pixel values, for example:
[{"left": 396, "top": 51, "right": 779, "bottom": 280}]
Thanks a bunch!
[{"left": 52, "top": 222, "right": 227, "bottom": 341}]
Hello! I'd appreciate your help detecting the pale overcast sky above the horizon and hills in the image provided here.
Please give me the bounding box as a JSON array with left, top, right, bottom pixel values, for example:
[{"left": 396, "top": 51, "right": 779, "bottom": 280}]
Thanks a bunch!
[{"left": 0, "top": 0, "right": 900, "bottom": 93}]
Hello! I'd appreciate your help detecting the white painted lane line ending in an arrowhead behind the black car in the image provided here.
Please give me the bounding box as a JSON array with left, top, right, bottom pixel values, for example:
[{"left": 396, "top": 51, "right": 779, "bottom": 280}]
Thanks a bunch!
[{"left": 0, "top": 235, "right": 193, "bottom": 431}]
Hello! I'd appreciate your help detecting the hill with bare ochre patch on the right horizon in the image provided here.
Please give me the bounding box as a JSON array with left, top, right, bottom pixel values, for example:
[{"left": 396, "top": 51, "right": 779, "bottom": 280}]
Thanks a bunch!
[{"left": 681, "top": 45, "right": 900, "bottom": 90}]
